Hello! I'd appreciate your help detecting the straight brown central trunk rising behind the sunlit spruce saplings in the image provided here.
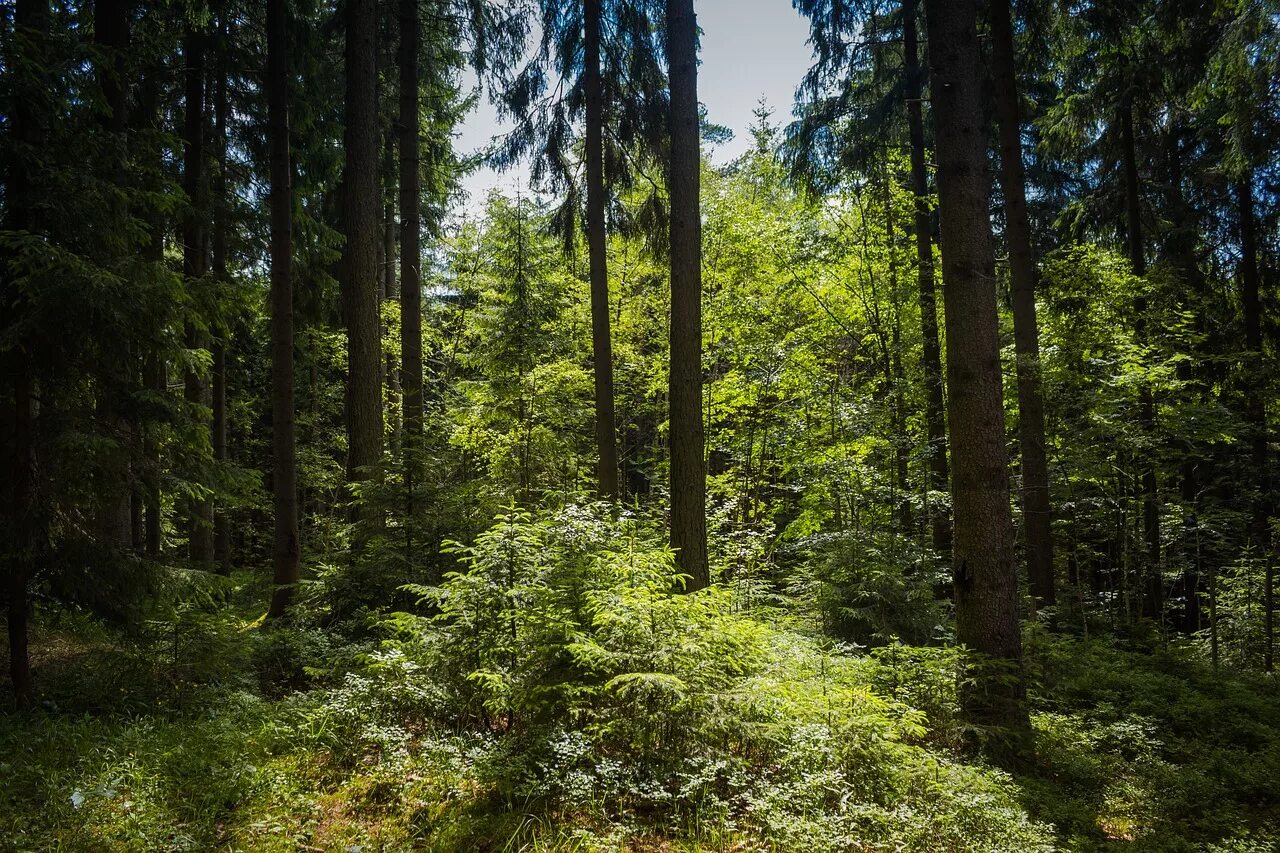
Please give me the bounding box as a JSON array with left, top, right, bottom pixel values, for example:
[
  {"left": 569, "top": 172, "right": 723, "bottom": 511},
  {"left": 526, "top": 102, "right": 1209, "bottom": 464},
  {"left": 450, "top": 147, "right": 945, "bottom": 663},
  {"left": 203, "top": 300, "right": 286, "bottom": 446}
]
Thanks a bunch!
[{"left": 667, "top": 0, "right": 710, "bottom": 589}]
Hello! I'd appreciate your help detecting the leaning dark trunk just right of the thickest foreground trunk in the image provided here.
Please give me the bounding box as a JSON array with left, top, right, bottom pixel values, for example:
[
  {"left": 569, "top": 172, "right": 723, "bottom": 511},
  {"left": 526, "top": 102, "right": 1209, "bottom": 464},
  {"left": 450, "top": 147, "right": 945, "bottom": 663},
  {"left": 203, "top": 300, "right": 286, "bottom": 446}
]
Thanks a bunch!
[{"left": 991, "top": 0, "right": 1056, "bottom": 605}]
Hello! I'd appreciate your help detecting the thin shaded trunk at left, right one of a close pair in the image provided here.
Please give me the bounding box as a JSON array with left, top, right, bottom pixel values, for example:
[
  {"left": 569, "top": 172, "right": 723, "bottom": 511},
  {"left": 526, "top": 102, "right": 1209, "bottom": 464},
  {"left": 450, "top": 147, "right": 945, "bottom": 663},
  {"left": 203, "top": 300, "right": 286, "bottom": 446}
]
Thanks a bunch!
[{"left": 212, "top": 23, "right": 232, "bottom": 574}]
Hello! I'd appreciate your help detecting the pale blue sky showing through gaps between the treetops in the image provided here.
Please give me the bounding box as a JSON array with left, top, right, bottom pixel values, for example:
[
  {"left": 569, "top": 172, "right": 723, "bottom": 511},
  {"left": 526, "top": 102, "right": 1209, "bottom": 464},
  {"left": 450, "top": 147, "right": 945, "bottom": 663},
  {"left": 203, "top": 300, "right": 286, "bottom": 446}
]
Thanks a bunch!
[{"left": 457, "top": 0, "right": 810, "bottom": 205}]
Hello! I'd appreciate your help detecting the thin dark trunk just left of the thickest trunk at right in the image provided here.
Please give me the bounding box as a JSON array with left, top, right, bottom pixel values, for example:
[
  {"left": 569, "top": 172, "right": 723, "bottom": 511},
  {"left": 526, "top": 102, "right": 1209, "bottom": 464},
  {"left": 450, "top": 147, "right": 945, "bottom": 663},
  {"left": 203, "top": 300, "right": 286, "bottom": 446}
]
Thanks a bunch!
[{"left": 902, "top": 0, "right": 951, "bottom": 557}]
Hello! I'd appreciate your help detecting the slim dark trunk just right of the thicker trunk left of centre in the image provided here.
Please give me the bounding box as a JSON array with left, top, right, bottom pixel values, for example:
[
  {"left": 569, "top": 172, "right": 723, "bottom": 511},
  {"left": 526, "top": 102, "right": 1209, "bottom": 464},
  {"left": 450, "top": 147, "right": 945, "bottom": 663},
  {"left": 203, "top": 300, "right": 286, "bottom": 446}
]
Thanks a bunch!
[{"left": 399, "top": 0, "right": 422, "bottom": 504}]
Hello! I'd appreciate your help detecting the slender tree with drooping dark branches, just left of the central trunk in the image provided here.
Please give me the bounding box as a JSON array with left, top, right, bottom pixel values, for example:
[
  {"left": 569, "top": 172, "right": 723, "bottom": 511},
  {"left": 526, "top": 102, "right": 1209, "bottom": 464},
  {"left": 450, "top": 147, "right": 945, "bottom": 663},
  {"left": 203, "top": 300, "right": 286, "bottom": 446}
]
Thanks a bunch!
[{"left": 495, "top": 0, "right": 666, "bottom": 498}]
